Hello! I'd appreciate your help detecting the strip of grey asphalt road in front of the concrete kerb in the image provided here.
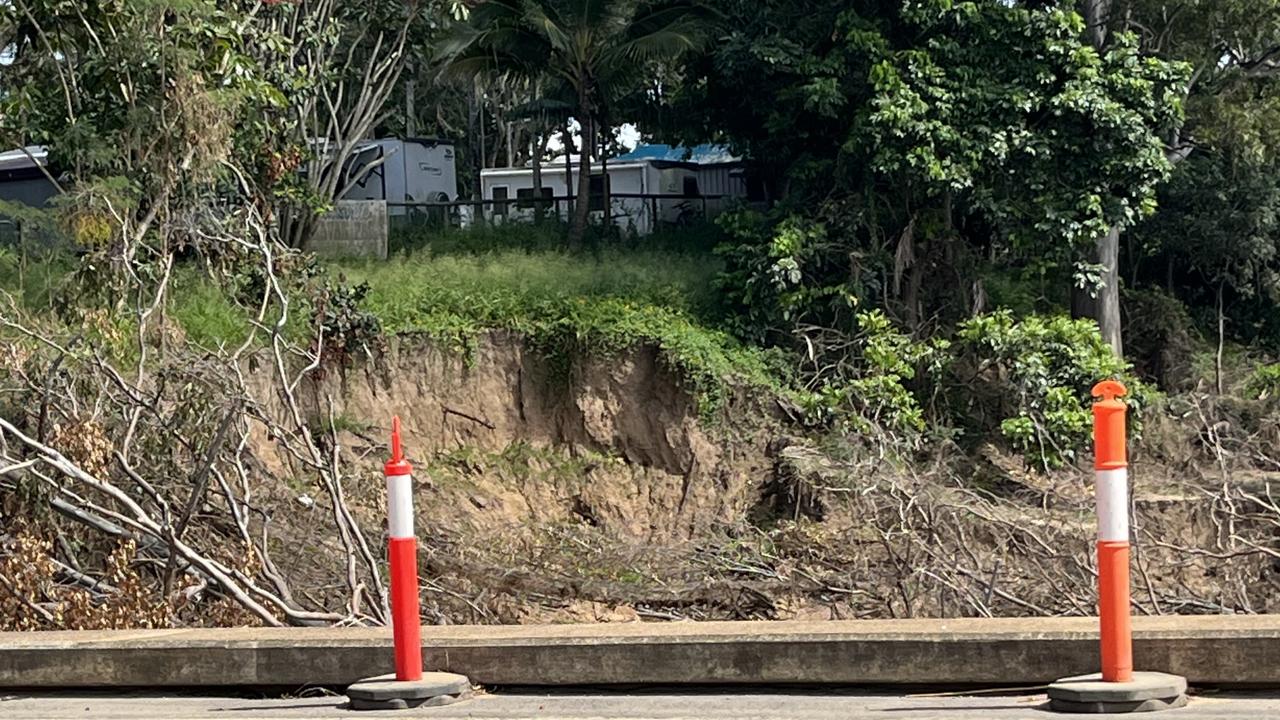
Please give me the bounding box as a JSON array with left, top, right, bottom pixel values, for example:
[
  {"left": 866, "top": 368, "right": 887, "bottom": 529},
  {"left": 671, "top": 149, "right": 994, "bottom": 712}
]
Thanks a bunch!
[{"left": 0, "top": 689, "right": 1280, "bottom": 720}]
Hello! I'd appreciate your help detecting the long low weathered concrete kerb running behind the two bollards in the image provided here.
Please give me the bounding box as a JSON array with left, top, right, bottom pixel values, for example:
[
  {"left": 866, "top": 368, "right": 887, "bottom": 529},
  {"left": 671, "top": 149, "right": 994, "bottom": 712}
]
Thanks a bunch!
[{"left": 0, "top": 615, "right": 1280, "bottom": 689}]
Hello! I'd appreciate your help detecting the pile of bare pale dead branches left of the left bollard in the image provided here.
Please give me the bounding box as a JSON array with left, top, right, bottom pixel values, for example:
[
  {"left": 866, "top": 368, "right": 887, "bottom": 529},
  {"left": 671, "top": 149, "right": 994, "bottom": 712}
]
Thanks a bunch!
[{"left": 0, "top": 209, "right": 387, "bottom": 628}]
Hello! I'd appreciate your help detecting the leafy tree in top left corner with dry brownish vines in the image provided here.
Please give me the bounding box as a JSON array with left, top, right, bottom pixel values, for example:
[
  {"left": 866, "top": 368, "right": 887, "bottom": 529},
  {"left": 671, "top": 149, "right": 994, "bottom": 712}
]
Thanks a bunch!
[{"left": 0, "top": 0, "right": 280, "bottom": 263}]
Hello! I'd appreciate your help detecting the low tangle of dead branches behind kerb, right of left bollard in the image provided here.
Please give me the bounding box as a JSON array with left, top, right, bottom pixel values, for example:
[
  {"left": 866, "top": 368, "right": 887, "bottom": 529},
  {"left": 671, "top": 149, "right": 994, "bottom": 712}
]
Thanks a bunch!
[{"left": 404, "top": 447, "right": 1280, "bottom": 623}]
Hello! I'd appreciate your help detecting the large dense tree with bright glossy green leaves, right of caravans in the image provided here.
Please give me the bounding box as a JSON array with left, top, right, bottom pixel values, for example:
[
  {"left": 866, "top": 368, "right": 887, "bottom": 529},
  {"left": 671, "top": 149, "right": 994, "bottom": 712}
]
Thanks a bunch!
[{"left": 667, "top": 0, "right": 1184, "bottom": 351}]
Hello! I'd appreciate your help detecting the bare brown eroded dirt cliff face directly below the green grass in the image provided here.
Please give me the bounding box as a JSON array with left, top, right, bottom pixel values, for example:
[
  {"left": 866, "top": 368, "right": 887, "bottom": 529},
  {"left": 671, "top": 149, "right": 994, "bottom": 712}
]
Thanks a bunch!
[{"left": 279, "top": 332, "right": 776, "bottom": 542}]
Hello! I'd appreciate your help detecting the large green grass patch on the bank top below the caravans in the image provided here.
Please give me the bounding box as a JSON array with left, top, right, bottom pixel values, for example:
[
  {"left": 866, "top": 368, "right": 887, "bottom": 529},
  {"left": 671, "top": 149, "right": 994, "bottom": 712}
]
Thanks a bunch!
[{"left": 334, "top": 228, "right": 785, "bottom": 415}]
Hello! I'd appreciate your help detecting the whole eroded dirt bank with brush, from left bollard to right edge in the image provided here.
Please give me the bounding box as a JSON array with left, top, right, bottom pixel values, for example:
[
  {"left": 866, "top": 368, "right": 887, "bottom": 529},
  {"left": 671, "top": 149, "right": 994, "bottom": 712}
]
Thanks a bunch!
[{"left": 244, "top": 333, "right": 1280, "bottom": 623}]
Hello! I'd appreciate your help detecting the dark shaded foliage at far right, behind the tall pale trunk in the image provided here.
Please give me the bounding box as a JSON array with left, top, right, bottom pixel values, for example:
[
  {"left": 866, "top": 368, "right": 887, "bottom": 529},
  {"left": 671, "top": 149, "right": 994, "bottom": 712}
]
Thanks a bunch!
[{"left": 1108, "top": 0, "right": 1280, "bottom": 368}]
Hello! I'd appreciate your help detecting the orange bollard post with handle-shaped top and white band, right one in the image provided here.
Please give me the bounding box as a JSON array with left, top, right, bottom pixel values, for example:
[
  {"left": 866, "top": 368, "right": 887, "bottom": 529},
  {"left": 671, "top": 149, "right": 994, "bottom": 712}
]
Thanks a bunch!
[{"left": 1093, "top": 380, "right": 1133, "bottom": 683}]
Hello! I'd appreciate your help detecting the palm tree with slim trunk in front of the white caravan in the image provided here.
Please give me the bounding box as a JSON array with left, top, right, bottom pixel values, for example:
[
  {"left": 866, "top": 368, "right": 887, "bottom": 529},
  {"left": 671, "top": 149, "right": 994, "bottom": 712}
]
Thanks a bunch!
[{"left": 442, "top": 0, "right": 709, "bottom": 246}]
